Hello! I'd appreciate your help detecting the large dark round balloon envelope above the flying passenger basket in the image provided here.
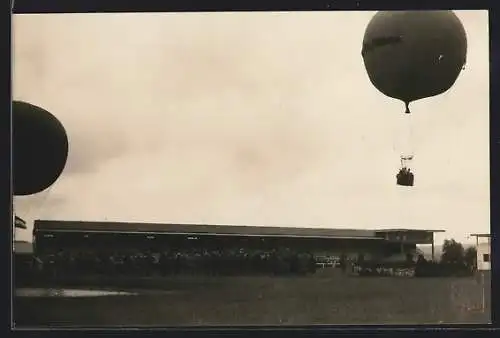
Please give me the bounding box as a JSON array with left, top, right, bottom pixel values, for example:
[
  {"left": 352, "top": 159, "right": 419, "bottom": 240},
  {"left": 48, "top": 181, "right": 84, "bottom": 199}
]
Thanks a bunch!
[{"left": 362, "top": 11, "right": 467, "bottom": 103}]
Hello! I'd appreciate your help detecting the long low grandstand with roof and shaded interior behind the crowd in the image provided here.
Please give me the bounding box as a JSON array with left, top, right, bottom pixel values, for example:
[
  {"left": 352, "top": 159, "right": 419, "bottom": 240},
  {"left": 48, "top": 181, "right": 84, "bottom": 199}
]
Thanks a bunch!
[{"left": 33, "top": 220, "right": 442, "bottom": 258}]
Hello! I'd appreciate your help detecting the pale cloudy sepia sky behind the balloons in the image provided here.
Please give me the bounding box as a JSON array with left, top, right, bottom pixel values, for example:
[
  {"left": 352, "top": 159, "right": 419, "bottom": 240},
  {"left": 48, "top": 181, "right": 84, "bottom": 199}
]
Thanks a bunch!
[{"left": 13, "top": 11, "right": 490, "bottom": 242}]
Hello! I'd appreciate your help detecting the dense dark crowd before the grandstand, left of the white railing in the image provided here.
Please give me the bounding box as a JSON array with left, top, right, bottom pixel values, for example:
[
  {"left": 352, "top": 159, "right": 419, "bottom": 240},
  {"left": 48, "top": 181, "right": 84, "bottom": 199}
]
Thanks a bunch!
[{"left": 28, "top": 249, "right": 316, "bottom": 276}]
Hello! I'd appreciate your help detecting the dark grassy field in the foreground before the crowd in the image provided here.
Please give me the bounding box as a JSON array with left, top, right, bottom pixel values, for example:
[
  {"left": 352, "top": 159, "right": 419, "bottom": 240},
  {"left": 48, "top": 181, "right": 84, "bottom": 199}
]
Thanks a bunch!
[{"left": 14, "top": 272, "right": 490, "bottom": 327}]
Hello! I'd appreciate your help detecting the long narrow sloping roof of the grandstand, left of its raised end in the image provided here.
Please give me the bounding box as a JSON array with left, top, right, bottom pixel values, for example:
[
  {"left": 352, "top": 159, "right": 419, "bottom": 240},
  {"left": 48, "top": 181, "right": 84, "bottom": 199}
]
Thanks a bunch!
[{"left": 34, "top": 220, "right": 382, "bottom": 240}]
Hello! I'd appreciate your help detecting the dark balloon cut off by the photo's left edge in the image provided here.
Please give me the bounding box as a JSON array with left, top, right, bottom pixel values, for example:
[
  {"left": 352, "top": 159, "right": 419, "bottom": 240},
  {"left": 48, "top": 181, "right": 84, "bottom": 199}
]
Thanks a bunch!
[{"left": 12, "top": 101, "right": 68, "bottom": 195}]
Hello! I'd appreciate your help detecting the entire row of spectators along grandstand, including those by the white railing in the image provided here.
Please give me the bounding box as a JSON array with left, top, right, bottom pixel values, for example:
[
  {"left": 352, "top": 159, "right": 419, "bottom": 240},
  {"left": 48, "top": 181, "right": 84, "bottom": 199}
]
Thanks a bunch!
[{"left": 14, "top": 243, "right": 438, "bottom": 278}]
